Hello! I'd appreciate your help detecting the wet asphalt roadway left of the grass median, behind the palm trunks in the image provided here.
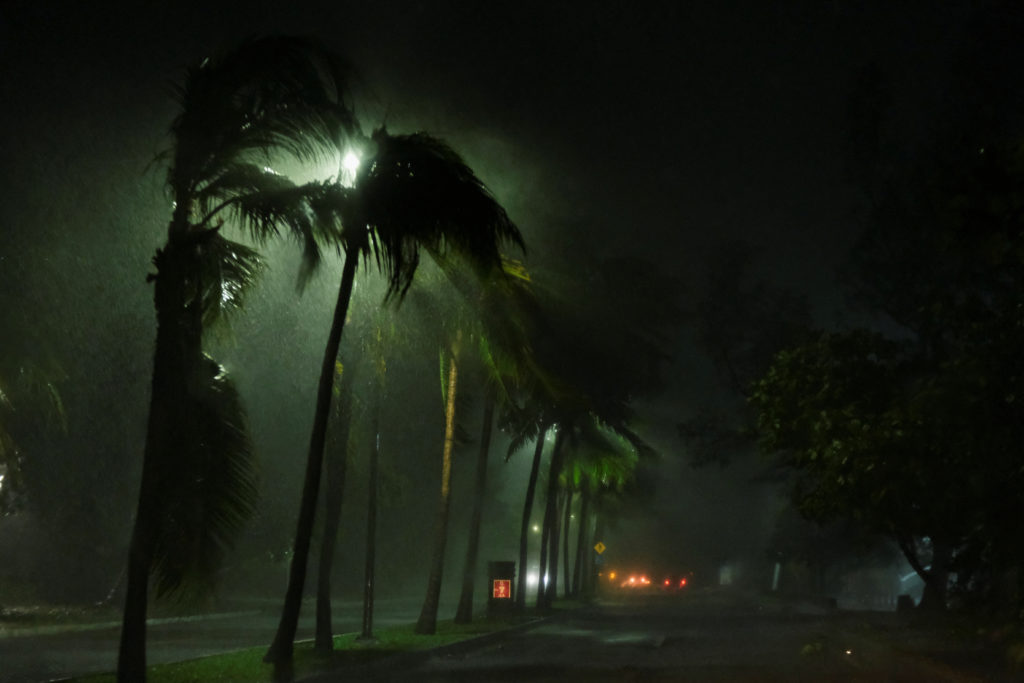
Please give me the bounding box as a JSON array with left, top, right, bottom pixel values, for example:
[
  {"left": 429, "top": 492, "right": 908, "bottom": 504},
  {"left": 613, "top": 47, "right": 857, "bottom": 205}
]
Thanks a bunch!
[{"left": 0, "top": 600, "right": 420, "bottom": 683}]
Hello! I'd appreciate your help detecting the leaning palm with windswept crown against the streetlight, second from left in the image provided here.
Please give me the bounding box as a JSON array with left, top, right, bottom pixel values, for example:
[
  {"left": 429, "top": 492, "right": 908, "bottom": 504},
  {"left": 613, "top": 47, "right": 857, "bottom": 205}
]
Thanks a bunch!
[{"left": 264, "top": 128, "right": 522, "bottom": 664}]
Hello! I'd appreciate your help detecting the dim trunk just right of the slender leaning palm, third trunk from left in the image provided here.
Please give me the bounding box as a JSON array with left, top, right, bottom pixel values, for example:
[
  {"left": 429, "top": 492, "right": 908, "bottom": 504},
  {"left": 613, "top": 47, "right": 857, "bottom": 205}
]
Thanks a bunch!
[{"left": 314, "top": 364, "right": 355, "bottom": 653}]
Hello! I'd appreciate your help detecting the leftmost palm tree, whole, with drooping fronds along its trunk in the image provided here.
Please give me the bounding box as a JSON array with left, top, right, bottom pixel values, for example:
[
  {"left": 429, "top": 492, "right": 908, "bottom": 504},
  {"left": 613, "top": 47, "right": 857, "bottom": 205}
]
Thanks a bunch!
[{"left": 118, "top": 37, "right": 351, "bottom": 682}]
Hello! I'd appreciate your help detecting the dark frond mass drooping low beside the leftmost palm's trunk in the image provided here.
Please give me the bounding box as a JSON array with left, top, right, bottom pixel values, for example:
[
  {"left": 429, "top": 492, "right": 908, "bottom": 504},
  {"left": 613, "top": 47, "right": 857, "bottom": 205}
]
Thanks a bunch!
[{"left": 150, "top": 356, "right": 258, "bottom": 598}]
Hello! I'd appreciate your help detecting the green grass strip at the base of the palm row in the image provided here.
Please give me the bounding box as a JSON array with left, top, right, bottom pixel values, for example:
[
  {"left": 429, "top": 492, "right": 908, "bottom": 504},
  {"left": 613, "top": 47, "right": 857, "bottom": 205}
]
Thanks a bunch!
[{"left": 72, "top": 617, "right": 530, "bottom": 683}]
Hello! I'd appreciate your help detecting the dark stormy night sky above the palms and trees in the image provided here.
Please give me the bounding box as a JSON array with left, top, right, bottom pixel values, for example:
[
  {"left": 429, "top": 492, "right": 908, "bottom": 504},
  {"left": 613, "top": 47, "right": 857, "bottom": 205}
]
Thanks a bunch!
[{"left": 0, "top": 0, "right": 1011, "bottom": 581}]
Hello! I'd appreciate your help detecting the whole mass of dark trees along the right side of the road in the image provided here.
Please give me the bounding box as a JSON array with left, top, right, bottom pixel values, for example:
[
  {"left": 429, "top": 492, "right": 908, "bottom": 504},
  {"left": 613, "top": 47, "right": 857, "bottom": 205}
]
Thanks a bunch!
[{"left": 679, "top": 1, "right": 1024, "bottom": 617}]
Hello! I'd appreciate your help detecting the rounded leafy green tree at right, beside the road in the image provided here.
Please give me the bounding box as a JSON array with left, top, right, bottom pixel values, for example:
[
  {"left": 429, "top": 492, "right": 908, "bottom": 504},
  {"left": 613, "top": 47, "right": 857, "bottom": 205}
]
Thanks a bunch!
[{"left": 752, "top": 323, "right": 1024, "bottom": 607}]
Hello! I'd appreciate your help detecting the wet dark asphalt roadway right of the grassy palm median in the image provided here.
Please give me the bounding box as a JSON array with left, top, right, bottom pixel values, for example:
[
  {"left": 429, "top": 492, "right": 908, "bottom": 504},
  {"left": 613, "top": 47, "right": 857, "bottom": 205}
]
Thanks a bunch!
[{"left": 307, "top": 594, "right": 1015, "bottom": 683}]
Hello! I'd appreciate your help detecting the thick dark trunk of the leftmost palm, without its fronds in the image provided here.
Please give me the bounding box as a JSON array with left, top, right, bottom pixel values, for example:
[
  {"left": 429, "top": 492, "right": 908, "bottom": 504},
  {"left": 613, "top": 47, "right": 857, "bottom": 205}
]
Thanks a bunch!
[{"left": 118, "top": 232, "right": 203, "bottom": 683}]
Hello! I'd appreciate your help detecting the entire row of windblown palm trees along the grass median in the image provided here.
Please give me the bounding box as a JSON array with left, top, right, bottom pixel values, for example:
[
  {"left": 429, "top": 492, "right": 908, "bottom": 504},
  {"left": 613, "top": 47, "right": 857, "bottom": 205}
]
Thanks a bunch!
[{"left": 118, "top": 37, "right": 649, "bottom": 681}]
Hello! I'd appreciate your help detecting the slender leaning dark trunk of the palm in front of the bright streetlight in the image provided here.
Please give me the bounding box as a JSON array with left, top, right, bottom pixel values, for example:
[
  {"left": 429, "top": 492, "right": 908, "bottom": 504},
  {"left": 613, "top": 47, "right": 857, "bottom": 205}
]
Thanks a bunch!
[{"left": 263, "top": 252, "right": 358, "bottom": 675}]
